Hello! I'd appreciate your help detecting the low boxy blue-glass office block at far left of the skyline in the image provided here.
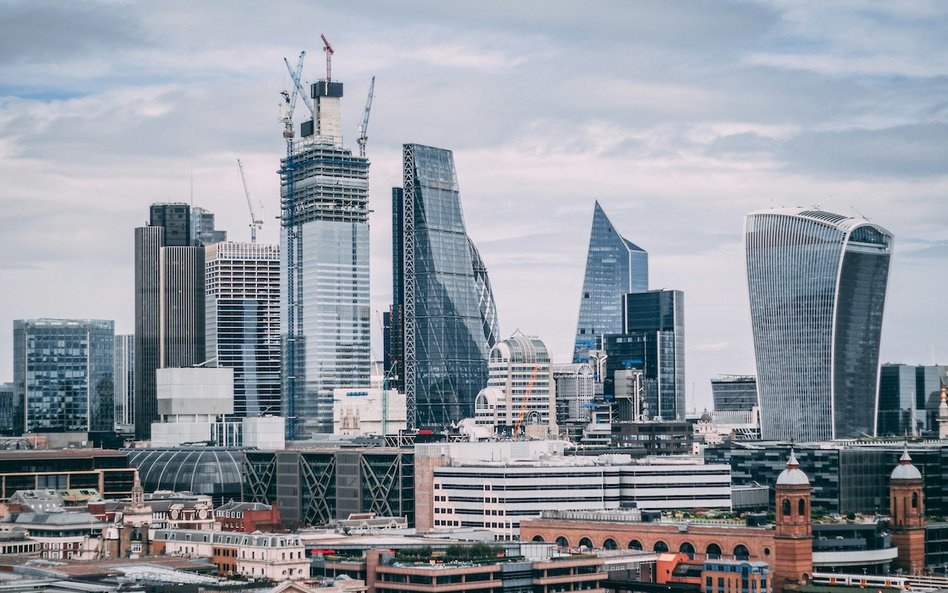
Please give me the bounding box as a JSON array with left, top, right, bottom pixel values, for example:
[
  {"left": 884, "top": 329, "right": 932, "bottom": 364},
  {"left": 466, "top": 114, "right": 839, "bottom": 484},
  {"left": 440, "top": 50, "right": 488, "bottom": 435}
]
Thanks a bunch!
[{"left": 13, "top": 319, "right": 115, "bottom": 432}]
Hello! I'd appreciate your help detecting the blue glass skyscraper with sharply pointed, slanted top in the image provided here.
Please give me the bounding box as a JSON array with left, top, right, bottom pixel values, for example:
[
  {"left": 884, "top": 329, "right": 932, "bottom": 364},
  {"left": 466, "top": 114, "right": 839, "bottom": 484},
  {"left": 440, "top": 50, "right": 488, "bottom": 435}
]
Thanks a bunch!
[{"left": 573, "top": 202, "right": 648, "bottom": 362}]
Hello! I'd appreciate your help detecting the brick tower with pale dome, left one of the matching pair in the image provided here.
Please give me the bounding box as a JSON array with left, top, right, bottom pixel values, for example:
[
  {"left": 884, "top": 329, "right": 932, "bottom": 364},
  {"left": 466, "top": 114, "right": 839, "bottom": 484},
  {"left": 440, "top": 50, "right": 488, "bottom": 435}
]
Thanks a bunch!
[{"left": 773, "top": 450, "right": 813, "bottom": 593}]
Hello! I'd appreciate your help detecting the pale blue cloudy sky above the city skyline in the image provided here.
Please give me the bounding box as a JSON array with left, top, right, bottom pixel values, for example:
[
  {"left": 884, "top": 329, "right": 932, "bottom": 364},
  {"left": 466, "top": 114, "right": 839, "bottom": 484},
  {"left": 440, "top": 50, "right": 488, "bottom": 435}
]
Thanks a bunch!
[{"left": 0, "top": 0, "right": 948, "bottom": 409}]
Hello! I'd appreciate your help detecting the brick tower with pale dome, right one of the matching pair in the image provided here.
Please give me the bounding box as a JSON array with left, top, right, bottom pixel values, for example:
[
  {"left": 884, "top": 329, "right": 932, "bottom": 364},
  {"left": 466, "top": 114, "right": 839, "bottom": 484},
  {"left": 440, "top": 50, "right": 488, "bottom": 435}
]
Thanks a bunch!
[{"left": 889, "top": 448, "right": 925, "bottom": 574}]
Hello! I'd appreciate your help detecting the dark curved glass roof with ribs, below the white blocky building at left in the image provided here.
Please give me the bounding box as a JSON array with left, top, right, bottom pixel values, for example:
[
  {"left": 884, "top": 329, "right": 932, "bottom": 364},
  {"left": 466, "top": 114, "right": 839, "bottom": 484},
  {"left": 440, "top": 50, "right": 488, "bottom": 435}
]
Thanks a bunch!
[{"left": 126, "top": 447, "right": 243, "bottom": 502}]
